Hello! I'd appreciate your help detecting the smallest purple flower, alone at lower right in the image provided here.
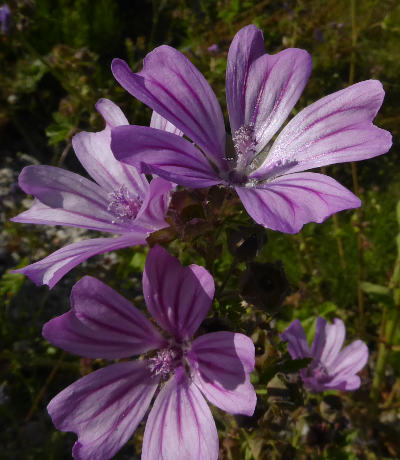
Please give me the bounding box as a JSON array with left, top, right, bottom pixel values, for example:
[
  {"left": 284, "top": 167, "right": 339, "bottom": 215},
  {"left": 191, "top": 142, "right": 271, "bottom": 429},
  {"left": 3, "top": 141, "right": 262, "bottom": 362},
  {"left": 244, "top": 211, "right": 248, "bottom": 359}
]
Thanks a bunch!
[{"left": 281, "top": 317, "right": 368, "bottom": 392}]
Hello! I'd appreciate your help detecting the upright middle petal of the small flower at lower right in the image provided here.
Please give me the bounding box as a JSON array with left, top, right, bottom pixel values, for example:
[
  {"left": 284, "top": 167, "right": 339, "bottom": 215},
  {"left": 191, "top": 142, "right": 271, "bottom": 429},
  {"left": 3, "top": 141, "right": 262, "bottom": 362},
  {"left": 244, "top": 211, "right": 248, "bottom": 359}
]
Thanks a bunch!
[{"left": 311, "top": 317, "right": 346, "bottom": 367}]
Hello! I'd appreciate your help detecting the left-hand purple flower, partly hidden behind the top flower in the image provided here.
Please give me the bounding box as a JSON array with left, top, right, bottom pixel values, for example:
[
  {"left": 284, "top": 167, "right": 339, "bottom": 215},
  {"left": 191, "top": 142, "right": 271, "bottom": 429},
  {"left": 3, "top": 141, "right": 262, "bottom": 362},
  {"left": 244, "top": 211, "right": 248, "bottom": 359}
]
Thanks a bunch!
[{"left": 11, "top": 99, "right": 180, "bottom": 288}]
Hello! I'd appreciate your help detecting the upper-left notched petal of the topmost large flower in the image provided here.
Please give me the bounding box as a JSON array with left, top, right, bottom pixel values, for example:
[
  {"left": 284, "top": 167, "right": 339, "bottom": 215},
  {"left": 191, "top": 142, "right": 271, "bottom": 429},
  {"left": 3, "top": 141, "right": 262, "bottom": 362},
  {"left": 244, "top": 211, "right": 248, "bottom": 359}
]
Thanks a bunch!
[{"left": 112, "top": 50, "right": 226, "bottom": 168}]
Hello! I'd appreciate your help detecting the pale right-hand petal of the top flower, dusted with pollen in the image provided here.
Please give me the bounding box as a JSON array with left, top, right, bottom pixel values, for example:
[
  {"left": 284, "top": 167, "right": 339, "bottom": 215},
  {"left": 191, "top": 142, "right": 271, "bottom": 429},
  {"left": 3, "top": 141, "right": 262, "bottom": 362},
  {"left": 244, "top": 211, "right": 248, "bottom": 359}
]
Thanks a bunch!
[{"left": 253, "top": 80, "right": 392, "bottom": 178}]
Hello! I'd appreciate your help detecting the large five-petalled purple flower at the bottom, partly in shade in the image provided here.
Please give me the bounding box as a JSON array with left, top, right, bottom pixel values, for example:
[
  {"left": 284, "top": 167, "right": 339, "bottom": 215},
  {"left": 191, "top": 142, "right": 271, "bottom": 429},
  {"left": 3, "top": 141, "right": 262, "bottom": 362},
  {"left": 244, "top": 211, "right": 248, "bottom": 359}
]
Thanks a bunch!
[{"left": 43, "top": 246, "right": 256, "bottom": 460}]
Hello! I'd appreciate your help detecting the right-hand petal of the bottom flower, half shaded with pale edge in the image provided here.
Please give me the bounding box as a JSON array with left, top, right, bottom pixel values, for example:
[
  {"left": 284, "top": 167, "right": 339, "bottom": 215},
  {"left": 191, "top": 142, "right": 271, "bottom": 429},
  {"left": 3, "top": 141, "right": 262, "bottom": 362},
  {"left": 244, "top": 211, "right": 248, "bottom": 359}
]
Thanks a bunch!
[{"left": 188, "top": 332, "right": 257, "bottom": 415}]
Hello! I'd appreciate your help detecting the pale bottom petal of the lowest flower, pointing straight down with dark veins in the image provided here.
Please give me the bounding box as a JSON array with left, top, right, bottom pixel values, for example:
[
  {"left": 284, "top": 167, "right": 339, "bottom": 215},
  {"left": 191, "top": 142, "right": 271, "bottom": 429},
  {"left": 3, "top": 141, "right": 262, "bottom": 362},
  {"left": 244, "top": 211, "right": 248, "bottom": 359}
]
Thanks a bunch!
[{"left": 142, "top": 368, "right": 218, "bottom": 460}]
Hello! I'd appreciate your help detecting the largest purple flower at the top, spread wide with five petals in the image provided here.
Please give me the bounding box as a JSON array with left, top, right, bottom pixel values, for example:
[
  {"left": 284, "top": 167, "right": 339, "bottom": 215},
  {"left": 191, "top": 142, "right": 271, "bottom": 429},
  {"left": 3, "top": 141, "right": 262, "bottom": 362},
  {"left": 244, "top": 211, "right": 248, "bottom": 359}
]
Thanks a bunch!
[{"left": 111, "top": 25, "right": 391, "bottom": 233}]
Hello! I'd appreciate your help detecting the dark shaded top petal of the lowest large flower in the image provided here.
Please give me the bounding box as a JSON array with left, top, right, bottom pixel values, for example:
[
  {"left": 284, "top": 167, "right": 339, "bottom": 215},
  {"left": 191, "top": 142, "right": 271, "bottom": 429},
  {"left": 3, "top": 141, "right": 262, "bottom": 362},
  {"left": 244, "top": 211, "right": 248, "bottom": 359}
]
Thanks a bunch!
[{"left": 143, "top": 246, "right": 214, "bottom": 340}]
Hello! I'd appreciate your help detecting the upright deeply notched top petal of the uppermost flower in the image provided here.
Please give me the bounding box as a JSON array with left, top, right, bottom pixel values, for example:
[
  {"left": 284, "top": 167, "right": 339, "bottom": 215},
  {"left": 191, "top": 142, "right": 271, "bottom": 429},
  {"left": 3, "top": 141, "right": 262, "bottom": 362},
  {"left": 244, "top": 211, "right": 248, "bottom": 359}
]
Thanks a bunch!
[{"left": 226, "top": 26, "right": 312, "bottom": 152}]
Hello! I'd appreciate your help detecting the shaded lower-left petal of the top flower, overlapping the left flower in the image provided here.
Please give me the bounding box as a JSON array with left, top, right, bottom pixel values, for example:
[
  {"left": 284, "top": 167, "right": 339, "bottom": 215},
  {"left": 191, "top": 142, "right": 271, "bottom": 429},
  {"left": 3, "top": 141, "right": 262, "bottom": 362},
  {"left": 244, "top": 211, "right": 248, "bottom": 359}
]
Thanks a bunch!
[{"left": 111, "top": 125, "right": 221, "bottom": 188}]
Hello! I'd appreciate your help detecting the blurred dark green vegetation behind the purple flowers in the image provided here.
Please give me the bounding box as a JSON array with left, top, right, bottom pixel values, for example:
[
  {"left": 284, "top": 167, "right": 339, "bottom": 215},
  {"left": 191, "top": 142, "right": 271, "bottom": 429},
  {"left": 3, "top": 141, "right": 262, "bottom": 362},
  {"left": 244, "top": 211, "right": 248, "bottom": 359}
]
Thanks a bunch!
[{"left": 0, "top": 0, "right": 400, "bottom": 460}]
